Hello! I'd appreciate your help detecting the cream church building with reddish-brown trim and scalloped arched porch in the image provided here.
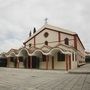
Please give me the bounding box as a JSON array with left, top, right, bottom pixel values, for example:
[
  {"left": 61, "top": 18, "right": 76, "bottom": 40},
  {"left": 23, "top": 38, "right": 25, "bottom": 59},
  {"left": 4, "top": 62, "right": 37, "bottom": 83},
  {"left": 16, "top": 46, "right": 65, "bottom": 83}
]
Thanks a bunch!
[{"left": 0, "top": 24, "right": 85, "bottom": 70}]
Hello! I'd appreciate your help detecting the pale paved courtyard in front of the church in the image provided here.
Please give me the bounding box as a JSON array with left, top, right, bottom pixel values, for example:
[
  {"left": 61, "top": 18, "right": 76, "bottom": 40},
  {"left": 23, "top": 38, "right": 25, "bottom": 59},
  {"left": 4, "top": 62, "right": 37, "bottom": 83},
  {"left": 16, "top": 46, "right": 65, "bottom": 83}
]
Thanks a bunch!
[{"left": 0, "top": 65, "right": 90, "bottom": 90}]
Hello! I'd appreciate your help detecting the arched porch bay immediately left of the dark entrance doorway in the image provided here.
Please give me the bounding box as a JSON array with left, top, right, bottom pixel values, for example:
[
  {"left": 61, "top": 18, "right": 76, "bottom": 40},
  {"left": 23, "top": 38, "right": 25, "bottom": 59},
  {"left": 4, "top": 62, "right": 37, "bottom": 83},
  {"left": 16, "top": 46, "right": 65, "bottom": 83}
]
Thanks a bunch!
[{"left": 17, "top": 48, "right": 29, "bottom": 68}]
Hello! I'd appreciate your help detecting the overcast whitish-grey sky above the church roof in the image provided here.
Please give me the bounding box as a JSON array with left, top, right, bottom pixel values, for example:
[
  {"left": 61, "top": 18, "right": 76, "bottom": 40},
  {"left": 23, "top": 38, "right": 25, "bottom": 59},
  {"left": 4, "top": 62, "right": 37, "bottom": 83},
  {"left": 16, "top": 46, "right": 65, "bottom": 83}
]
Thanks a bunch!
[{"left": 0, "top": 0, "right": 90, "bottom": 52}]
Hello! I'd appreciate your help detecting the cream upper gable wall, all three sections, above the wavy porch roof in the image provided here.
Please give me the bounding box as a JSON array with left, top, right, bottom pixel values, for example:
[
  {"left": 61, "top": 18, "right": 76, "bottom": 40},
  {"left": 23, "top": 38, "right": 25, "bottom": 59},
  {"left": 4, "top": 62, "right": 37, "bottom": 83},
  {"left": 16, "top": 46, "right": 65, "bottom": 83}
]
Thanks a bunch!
[{"left": 26, "top": 29, "right": 74, "bottom": 48}]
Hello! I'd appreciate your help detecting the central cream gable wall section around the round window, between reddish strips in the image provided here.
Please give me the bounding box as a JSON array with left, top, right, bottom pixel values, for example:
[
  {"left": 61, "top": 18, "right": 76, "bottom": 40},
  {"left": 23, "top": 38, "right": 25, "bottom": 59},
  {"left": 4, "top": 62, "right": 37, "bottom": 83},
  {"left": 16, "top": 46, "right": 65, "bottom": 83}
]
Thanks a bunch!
[{"left": 35, "top": 29, "right": 58, "bottom": 48}]
